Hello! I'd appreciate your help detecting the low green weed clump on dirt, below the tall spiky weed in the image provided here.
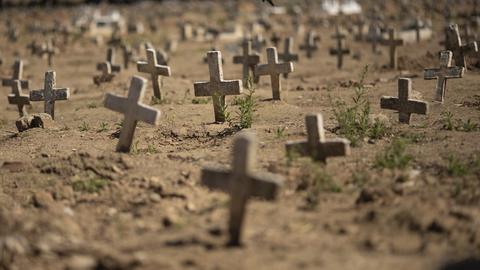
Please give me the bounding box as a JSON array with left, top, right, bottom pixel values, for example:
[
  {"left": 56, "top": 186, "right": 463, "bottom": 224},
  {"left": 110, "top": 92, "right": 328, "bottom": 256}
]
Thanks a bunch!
[{"left": 375, "top": 138, "right": 413, "bottom": 170}]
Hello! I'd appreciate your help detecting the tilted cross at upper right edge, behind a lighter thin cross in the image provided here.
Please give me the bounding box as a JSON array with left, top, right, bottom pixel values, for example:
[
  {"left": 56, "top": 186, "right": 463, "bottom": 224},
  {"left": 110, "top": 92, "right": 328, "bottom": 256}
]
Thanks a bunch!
[{"left": 445, "top": 24, "right": 478, "bottom": 70}]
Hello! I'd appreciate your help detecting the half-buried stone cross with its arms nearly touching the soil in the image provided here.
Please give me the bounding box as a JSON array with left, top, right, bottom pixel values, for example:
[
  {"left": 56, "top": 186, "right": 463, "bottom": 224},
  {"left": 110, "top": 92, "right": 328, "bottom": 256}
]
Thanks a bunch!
[{"left": 286, "top": 114, "right": 350, "bottom": 163}]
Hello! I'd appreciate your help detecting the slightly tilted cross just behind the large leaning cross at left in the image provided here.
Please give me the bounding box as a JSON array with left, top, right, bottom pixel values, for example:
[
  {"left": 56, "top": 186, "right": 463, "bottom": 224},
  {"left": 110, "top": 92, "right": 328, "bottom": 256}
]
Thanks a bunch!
[{"left": 137, "top": 49, "right": 171, "bottom": 100}]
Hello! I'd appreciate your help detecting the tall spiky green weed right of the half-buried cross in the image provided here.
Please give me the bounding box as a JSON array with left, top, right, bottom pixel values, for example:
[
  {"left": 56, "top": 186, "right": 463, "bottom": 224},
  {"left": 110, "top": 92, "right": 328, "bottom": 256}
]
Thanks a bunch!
[{"left": 328, "top": 66, "right": 388, "bottom": 146}]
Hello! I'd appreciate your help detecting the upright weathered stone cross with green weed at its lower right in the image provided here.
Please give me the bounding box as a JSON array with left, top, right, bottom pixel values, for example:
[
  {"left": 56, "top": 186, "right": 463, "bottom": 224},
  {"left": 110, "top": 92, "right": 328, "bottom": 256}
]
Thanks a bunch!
[{"left": 193, "top": 51, "right": 243, "bottom": 123}]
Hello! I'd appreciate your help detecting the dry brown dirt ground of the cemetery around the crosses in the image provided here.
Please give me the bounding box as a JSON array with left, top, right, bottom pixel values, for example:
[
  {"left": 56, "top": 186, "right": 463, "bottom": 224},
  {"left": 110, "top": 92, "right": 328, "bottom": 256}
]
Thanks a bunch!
[{"left": 0, "top": 1, "right": 480, "bottom": 270}]
